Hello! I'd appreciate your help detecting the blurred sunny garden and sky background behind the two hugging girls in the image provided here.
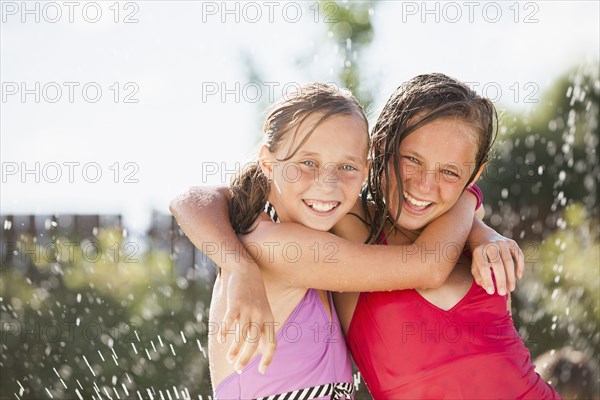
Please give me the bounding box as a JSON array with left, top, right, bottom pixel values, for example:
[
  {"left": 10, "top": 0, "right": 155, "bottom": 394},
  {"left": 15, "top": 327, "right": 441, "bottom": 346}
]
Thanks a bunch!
[{"left": 0, "top": 1, "right": 600, "bottom": 399}]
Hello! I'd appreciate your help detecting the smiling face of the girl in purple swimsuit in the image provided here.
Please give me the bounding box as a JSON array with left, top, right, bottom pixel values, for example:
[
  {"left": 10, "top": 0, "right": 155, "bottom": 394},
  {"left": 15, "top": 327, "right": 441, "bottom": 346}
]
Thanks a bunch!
[{"left": 261, "top": 113, "right": 368, "bottom": 231}]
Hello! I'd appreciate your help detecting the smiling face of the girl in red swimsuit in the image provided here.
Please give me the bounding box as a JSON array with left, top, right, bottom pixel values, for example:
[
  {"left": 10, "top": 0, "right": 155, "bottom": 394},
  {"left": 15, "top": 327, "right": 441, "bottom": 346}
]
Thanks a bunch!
[{"left": 382, "top": 118, "right": 477, "bottom": 230}]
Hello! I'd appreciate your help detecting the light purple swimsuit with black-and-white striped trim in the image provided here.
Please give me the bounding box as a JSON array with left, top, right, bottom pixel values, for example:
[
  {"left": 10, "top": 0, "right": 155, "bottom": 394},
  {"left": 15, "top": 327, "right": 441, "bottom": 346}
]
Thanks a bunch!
[{"left": 215, "top": 289, "right": 354, "bottom": 400}]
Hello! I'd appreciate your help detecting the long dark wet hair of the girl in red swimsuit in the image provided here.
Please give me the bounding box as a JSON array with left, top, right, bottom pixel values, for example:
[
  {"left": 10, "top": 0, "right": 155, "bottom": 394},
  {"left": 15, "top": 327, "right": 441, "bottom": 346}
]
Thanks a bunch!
[{"left": 361, "top": 73, "right": 498, "bottom": 243}]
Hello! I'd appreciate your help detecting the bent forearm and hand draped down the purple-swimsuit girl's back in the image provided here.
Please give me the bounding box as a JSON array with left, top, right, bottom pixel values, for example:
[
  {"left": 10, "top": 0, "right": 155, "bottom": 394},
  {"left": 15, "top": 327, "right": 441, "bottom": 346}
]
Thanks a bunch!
[{"left": 169, "top": 187, "right": 277, "bottom": 371}]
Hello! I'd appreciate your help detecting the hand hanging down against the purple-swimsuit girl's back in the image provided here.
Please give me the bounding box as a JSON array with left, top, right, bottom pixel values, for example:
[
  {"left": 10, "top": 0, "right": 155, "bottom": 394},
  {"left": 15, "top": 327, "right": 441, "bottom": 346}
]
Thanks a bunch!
[{"left": 220, "top": 264, "right": 277, "bottom": 374}]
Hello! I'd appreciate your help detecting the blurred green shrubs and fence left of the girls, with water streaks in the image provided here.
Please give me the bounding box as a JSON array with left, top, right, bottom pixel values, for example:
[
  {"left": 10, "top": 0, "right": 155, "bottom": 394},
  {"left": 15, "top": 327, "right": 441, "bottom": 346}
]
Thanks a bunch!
[{"left": 0, "top": 227, "right": 216, "bottom": 399}]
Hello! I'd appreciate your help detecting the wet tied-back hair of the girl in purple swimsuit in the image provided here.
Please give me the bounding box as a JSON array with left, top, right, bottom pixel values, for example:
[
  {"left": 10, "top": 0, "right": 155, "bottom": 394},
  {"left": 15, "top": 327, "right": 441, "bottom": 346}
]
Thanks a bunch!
[{"left": 229, "top": 83, "right": 369, "bottom": 233}]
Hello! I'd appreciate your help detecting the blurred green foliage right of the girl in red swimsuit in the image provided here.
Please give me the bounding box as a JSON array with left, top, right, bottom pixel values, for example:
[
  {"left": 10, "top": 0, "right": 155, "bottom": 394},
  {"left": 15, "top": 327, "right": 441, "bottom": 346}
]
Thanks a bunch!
[{"left": 478, "top": 64, "right": 600, "bottom": 357}]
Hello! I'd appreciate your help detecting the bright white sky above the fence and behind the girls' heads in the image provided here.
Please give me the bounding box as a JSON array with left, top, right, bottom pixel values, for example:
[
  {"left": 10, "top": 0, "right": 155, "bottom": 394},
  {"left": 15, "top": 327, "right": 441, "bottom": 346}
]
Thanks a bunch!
[{"left": 0, "top": 1, "right": 600, "bottom": 229}]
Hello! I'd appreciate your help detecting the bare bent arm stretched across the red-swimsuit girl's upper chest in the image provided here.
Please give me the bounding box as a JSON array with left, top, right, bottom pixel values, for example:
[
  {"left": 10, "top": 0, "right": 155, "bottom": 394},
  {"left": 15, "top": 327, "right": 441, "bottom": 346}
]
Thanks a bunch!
[{"left": 242, "top": 193, "right": 476, "bottom": 291}]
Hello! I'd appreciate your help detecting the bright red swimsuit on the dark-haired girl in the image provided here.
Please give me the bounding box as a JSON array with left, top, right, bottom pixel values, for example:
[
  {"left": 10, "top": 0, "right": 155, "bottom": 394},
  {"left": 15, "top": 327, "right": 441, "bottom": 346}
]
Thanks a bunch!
[{"left": 346, "top": 241, "right": 560, "bottom": 400}]
